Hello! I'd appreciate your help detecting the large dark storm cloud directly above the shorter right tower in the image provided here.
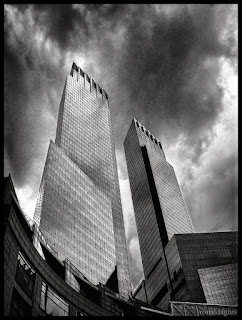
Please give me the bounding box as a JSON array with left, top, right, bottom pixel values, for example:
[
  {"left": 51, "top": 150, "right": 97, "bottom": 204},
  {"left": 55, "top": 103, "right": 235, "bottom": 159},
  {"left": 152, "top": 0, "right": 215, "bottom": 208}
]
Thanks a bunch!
[{"left": 114, "top": 6, "right": 234, "bottom": 151}]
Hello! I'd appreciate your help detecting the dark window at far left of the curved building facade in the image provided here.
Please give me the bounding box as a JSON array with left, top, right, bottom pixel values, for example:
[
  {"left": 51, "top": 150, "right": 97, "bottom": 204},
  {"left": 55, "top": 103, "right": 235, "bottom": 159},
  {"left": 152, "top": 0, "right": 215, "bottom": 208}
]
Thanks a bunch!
[{"left": 15, "top": 251, "right": 35, "bottom": 297}]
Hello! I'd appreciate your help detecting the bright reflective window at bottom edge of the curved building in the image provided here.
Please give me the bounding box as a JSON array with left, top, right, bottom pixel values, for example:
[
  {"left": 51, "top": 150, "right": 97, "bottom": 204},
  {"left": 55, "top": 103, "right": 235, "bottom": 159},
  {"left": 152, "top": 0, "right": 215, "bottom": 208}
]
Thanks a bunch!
[{"left": 40, "top": 281, "right": 69, "bottom": 316}]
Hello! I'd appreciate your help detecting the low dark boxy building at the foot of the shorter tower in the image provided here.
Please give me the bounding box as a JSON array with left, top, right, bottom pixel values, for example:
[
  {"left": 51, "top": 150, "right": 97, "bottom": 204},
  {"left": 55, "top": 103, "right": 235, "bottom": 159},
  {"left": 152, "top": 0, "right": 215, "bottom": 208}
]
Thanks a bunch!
[{"left": 134, "top": 231, "right": 238, "bottom": 310}]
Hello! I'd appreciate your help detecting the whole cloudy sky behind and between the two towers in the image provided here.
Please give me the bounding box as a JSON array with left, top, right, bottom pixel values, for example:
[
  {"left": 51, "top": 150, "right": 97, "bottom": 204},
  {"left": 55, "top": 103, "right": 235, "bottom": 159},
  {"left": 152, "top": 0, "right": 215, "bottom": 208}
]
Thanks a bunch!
[{"left": 4, "top": 4, "right": 238, "bottom": 287}]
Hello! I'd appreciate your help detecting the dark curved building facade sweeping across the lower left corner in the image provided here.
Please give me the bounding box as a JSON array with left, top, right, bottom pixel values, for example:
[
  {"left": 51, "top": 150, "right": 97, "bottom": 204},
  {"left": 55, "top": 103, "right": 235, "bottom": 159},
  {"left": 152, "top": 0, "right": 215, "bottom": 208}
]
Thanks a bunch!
[{"left": 4, "top": 176, "right": 170, "bottom": 316}]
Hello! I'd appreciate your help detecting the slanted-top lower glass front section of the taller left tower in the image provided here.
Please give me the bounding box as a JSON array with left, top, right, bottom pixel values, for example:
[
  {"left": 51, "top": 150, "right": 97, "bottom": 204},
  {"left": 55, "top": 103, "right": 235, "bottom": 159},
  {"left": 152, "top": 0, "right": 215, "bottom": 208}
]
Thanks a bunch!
[{"left": 34, "top": 142, "right": 116, "bottom": 284}]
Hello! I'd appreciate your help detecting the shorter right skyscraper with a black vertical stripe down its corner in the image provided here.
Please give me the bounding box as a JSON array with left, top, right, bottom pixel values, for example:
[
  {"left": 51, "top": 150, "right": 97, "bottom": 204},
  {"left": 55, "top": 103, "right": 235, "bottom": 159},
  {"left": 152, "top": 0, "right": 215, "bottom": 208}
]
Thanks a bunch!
[{"left": 124, "top": 119, "right": 193, "bottom": 303}]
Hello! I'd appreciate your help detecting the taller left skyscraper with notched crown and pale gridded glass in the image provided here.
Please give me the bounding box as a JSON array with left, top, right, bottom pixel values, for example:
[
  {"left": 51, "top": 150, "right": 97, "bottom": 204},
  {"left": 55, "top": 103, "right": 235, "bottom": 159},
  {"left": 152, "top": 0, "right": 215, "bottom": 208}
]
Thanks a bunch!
[{"left": 34, "top": 63, "right": 131, "bottom": 298}]
